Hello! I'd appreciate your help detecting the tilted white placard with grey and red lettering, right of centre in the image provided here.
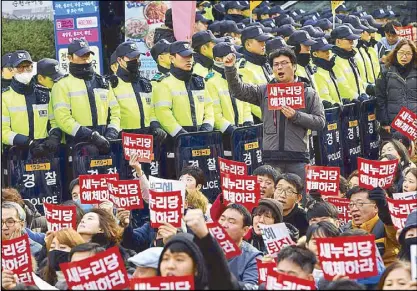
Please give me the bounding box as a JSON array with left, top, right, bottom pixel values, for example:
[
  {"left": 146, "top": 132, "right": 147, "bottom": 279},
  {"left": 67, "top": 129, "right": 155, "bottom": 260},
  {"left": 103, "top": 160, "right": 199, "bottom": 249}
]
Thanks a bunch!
[{"left": 259, "top": 223, "right": 295, "bottom": 256}]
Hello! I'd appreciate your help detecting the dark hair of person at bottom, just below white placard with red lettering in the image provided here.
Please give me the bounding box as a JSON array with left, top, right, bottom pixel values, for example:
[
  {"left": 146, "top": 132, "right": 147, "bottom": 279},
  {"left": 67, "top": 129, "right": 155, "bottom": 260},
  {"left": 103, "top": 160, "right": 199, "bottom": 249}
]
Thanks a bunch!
[{"left": 277, "top": 245, "right": 317, "bottom": 274}]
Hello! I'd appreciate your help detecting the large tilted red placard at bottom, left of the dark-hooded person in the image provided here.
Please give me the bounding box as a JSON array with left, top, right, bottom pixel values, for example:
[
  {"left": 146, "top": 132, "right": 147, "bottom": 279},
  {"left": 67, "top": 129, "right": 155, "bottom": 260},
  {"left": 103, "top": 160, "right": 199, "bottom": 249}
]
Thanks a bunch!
[{"left": 59, "top": 247, "right": 129, "bottom": 290}]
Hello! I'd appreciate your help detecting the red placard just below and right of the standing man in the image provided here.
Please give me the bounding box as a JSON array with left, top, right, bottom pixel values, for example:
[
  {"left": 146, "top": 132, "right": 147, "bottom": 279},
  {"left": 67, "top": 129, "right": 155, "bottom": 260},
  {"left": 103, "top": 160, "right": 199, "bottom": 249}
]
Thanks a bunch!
[{"left": 305, "top": 166, "right": 340, "bottom": 196}]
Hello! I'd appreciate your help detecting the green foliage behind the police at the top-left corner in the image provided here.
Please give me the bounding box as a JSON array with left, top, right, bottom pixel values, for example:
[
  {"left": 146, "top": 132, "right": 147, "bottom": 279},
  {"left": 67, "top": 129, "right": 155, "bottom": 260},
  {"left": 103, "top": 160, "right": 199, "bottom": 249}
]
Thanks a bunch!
[{"left": 1, "top": 17, "right": 55, "bottom": 62}]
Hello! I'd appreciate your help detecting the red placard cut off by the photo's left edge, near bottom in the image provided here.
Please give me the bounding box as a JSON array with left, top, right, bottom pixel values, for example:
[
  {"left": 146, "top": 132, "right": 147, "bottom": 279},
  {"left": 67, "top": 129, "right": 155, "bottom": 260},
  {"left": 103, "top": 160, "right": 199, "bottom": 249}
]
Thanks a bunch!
[{"left": 1, "top": 234, "right": 35, "bottom": 285}]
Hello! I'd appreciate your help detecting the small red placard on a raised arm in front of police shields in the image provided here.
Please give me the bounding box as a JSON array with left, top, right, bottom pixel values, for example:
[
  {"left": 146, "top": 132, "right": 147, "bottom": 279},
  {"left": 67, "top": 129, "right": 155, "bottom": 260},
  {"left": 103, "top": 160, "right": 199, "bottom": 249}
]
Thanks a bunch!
[{"left": 122, "top": 132, "right": 153, "bottom": 163}]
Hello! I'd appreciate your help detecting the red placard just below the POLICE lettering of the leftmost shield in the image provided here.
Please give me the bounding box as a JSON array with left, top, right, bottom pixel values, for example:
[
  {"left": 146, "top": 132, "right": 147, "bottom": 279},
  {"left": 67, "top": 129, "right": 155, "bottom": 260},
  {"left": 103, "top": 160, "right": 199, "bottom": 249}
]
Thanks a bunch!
[{"left": 43, "top": 202, "right": 77, "bottom": 231}]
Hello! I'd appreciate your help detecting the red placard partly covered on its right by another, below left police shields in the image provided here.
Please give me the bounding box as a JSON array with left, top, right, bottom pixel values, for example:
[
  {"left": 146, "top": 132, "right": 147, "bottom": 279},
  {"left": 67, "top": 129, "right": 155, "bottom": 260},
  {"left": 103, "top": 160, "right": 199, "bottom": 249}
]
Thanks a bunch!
[{"left": 79, "top": 174, "right": 119, "bottom": 204}]
